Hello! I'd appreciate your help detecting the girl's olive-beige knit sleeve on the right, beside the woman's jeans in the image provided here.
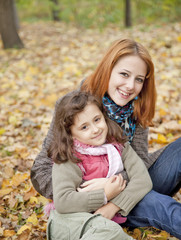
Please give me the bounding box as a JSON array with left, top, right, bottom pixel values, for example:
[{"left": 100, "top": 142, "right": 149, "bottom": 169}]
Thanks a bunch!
[{"left": 111, "top": 143, "right": 152, "bottom": 216}]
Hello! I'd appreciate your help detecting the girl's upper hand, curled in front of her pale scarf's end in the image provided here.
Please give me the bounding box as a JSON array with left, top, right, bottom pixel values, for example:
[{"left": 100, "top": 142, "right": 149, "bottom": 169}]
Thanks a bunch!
[{"left": 104, "top": 174, "right": 126, "bottom": 201}]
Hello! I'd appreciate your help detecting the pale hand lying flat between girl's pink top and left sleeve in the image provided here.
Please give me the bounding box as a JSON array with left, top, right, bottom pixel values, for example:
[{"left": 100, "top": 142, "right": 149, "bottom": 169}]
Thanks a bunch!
[{"left": 77, "top": 178, "right": 109, "bottom": 192}]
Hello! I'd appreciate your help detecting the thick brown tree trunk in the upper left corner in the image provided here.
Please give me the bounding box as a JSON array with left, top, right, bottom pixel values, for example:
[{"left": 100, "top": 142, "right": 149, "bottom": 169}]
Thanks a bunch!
[{"left": 0, "top": 0, "right": 24, "bottom": 48}]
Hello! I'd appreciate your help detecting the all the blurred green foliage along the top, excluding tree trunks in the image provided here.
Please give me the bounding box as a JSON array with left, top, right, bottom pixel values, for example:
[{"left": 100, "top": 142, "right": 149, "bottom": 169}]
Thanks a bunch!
[{"left": 16, "top": 0, "right": 181, "bottom": 28}]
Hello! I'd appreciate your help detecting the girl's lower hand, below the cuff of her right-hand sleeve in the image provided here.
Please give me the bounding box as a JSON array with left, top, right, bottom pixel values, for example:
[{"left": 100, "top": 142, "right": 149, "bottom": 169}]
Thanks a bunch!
[{"left": 94, "top": 202, "right": 120, "bottom": 220}]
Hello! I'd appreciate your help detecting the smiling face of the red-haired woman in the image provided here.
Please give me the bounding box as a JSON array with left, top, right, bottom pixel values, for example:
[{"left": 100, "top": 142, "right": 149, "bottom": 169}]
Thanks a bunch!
[{"left": 108, "top": 55, "right": 147, "bottom": 106}]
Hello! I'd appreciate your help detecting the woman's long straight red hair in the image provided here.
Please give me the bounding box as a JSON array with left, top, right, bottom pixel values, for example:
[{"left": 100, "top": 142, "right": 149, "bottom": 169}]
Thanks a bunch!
[{"left": 81, "top": 39, "right": 156, "bottom": 127}]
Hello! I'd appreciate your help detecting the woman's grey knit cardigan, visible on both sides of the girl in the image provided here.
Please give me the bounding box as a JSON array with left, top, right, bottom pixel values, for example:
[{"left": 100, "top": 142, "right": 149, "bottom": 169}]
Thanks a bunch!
[{"left": 31, "top": 98, "right": 165, "bottom": 199}]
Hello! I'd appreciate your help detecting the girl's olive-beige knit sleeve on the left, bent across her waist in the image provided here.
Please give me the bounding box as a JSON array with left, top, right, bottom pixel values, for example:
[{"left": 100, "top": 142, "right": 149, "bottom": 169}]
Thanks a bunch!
[{"left": 52, "top": 161, "right": 104, "bottom": 213}]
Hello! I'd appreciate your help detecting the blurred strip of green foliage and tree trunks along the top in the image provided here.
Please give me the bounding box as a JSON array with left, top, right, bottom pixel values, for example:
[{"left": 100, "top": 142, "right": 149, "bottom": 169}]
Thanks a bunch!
[{"left": 0, "top": 0, "right": 181, "bottom": 48}]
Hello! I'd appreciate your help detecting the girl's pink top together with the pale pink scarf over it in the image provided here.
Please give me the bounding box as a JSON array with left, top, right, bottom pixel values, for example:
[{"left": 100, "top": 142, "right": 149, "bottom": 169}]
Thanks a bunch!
[{"left": 74, "top": 139, "right": 124, "bottom": 180}]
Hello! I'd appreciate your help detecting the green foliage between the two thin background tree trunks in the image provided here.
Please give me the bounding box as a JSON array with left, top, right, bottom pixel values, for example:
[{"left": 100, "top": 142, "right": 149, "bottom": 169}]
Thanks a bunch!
[{"left": 60, "top": 0, "right": 123, "bottom": 27}]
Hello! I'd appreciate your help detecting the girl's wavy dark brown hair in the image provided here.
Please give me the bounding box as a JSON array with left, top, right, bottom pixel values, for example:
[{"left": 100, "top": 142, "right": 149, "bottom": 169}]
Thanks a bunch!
[{"left": 48, "top": 91, "right": 125, "bottom": 163}]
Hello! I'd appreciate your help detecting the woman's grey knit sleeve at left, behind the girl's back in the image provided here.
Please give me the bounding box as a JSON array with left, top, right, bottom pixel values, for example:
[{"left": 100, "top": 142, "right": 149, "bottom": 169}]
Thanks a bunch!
[{"left": 31, "top": 98, "right": 61, "bottom": 199}]
